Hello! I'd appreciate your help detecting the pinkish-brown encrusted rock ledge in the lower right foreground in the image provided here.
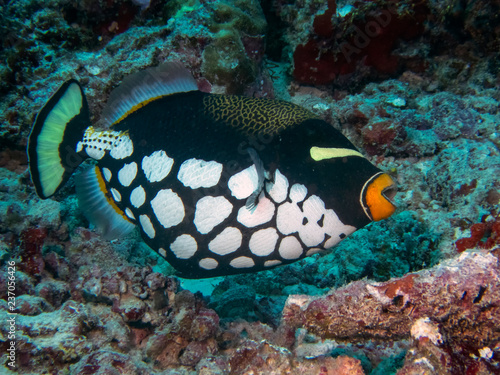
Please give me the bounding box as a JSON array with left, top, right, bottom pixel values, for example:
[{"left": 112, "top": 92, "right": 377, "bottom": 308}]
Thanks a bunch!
[{"left": 283, "top": 249, "right": 500, "bottom": 374}]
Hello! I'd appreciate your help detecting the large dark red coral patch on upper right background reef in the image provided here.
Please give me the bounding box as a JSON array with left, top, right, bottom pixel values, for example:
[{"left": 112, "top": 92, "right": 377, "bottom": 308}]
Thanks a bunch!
[{"left": 293, "top": 0, "right": 429, "bottom": 84}]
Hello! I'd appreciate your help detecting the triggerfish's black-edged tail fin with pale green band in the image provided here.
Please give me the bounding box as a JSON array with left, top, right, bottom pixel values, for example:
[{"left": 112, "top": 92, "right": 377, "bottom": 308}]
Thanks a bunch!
[{"left": 27, "top": 79, "right": 90, "bottom": 199}]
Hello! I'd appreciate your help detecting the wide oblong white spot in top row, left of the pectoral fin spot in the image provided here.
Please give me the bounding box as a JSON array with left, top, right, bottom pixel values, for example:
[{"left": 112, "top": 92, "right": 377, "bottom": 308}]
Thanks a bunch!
[{"left": 177, "top": 159, "right": 222, "bottom": 189}]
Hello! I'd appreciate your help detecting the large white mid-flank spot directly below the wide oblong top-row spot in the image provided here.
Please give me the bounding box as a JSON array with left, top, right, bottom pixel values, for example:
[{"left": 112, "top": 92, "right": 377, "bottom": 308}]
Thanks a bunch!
[{"left": 194, "top": 196, "right": 233, "bottom": 234}]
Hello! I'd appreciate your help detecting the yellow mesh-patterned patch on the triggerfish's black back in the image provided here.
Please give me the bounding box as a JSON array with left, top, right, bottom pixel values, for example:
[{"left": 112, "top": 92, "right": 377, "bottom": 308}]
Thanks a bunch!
[{"left": 203, "top": 95, "right": 317, "bottom": 135}]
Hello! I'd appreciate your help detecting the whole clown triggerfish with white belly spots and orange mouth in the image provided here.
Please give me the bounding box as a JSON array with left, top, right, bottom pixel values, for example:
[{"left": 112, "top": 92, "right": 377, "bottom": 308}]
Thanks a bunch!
[{"left": 28, "top": 63, "right": 396, "bottom": 278}]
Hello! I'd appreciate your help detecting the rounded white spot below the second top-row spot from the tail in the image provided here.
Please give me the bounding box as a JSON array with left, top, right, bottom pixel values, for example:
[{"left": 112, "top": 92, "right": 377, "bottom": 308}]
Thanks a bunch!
[{"left": 151, "top": 189, "right": 184, "bottom": 228}]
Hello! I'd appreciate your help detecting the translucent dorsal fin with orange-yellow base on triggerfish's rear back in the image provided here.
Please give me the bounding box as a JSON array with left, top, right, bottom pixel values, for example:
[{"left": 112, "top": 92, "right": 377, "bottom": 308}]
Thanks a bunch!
[{"left": 101, "top": 62, "right": 198, "bottom": 127}]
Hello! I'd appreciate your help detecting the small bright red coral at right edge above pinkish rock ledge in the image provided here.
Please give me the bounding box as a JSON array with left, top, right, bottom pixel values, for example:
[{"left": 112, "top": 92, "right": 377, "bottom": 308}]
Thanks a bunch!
[{"left": 455, "top": 215, "right": 500, "bottom": 253}]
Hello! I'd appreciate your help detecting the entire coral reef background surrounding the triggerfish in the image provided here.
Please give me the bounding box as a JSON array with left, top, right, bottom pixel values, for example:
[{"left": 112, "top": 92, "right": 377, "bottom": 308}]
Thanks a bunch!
[{"left": 0, "top": 0, "right": 500, "bottom": 375}]
